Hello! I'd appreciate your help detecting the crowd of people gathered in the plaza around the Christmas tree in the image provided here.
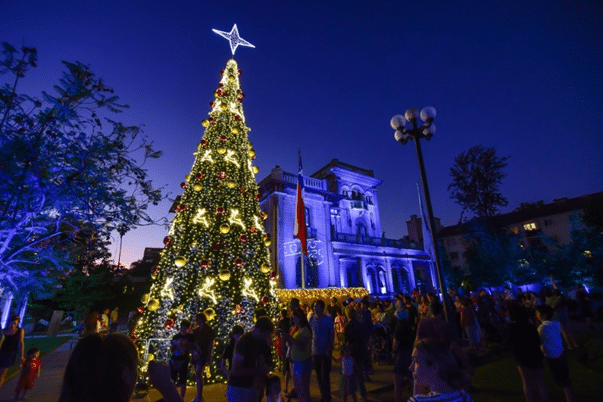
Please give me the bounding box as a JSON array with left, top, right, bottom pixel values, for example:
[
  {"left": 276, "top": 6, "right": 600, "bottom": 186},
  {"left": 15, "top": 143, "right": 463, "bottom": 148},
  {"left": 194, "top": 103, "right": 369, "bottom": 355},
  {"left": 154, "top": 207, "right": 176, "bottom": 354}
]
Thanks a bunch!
[{"left": 0, "top": 282, "right": 593, "bottom": 402}]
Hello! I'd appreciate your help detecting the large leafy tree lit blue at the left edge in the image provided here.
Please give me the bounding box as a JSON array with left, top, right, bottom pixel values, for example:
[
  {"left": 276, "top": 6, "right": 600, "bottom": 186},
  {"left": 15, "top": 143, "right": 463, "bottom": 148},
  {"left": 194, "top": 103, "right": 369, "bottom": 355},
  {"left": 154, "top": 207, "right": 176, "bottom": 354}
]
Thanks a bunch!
[{"left": 0, "top": 43, "right": 162, "bottom": 298}]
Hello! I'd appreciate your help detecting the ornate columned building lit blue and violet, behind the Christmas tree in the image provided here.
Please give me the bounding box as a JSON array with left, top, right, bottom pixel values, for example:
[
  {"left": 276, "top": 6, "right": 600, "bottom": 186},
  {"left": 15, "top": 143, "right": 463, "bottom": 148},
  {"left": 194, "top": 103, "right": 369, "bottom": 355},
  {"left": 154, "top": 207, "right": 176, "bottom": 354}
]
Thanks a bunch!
[{"left": 260, "top": 159, "right": 437, "bottom": 295}]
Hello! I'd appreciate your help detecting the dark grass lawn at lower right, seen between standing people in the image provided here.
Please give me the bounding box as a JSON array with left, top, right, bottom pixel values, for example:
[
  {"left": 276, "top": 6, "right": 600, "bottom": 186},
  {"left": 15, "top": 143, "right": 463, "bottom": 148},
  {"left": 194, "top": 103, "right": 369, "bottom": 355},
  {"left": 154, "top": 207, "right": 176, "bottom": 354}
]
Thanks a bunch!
[{"left": 471, "top": 350, "right": 603, "bottom": 402}]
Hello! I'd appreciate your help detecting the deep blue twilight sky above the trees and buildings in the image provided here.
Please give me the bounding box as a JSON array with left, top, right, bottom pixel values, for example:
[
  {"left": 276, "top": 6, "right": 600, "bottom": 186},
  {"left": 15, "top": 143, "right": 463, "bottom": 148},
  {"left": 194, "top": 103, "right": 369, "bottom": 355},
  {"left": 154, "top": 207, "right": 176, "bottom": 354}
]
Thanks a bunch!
[{"left": 0, "top": 0, "right": 603, "bottom": 263}]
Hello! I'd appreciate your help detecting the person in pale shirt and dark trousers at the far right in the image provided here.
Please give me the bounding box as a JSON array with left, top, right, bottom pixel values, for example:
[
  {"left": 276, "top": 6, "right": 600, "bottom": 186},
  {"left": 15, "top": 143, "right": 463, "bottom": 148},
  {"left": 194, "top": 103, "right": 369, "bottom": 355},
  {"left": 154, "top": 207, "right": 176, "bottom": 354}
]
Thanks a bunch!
[{"left": 536, "top": 304, "right": 576, "bottom": 402}]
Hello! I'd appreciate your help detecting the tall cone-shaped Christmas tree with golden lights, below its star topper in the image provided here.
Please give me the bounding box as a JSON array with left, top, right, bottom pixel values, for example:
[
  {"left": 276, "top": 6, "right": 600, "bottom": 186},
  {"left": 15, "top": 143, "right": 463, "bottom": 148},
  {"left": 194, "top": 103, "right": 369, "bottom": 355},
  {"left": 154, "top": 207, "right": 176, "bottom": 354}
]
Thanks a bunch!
[{"left": 133, "top": 59, "right": 276, "bottom": 383}]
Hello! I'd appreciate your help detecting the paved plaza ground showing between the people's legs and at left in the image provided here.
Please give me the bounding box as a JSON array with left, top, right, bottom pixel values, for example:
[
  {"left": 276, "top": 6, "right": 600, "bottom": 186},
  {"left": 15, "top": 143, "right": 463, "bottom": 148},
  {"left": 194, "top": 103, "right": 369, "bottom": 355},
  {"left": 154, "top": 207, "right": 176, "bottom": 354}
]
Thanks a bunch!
[{"left": 0, "top": 340, "right": 394, "bottom": 402}]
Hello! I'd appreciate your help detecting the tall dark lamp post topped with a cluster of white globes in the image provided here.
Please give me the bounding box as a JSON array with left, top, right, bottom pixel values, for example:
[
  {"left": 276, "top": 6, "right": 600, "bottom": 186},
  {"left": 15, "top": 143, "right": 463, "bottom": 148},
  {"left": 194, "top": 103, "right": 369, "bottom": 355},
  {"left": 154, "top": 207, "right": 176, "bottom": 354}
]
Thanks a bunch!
[{"left": 391, "top": 106, "right": 450, "bottom": 321}]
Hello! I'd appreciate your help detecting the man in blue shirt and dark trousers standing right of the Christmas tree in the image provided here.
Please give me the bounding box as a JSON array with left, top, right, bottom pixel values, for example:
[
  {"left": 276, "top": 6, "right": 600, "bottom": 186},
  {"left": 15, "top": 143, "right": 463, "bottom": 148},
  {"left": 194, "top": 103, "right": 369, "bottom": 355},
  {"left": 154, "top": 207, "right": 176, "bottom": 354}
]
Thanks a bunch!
[{"left": 309, "top": 300, "right": 334, "bottom": 402}]
